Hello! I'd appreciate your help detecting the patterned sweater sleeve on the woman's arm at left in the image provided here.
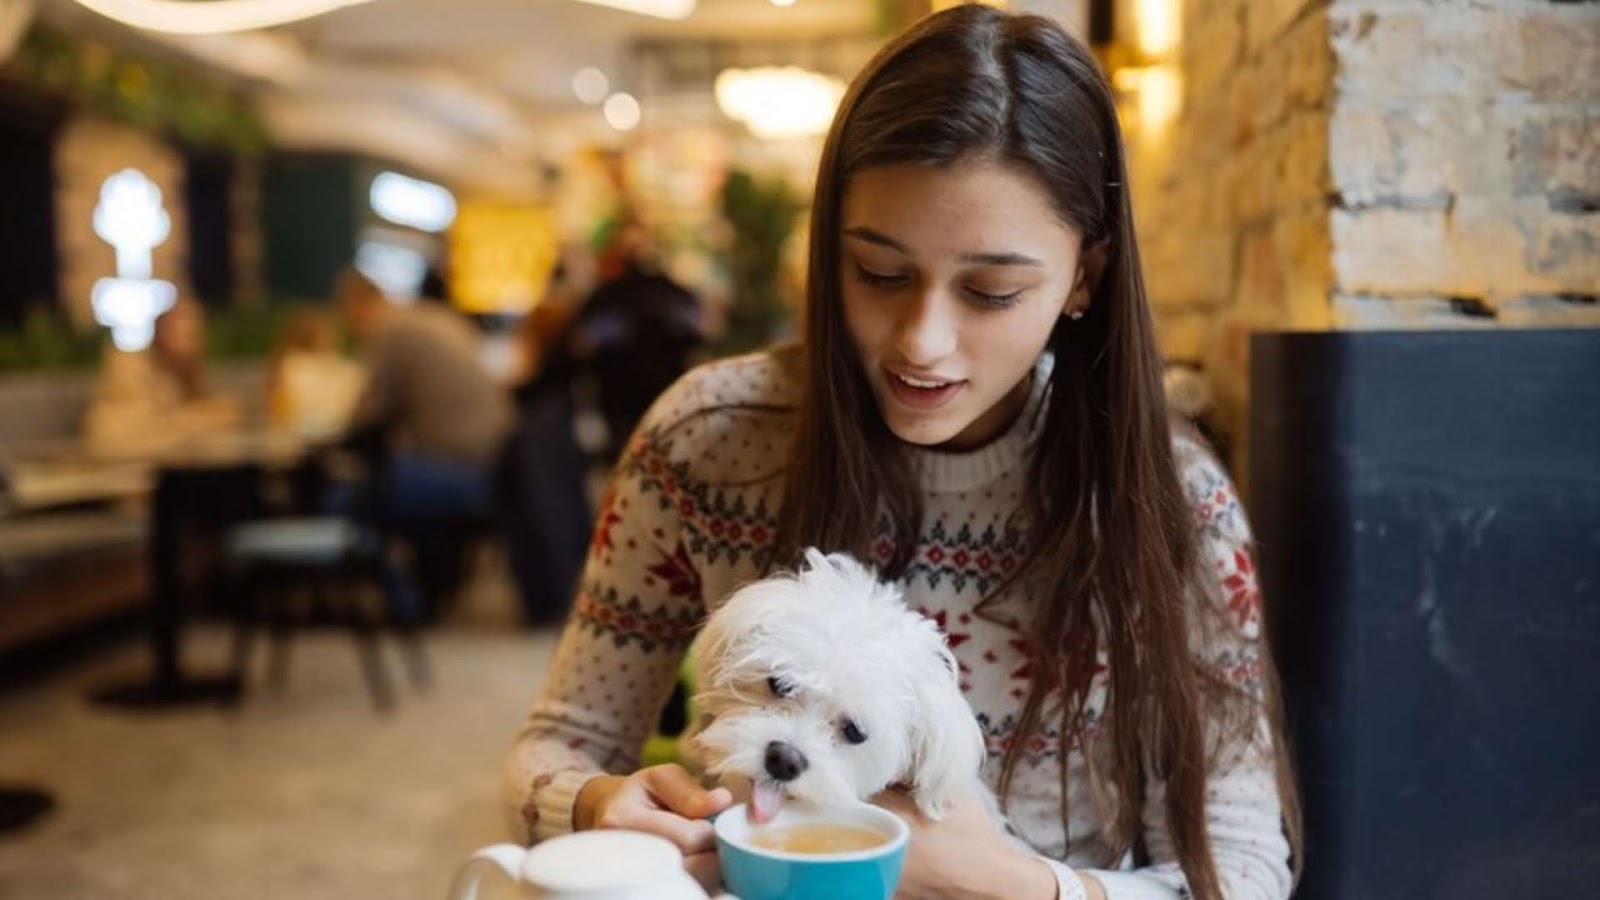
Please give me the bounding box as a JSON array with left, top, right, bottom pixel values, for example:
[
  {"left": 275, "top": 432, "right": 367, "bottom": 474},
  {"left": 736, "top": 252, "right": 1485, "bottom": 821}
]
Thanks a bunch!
[{"left": 506, "top": 381, "right": 704, "bottom": 842}]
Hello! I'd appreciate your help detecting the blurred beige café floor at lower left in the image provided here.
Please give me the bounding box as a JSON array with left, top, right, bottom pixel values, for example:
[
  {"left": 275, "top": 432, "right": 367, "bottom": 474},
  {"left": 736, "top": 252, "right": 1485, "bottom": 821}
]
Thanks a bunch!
[{"left": 0, "top": 570, "right": 554, "bottom": 900}]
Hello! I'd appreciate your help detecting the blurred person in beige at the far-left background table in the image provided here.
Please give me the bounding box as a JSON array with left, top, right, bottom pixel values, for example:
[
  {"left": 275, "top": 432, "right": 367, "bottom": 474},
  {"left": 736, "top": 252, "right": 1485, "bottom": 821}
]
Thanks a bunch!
[{"left": 83, "top": 298, "right": 240, "bottom": 456}]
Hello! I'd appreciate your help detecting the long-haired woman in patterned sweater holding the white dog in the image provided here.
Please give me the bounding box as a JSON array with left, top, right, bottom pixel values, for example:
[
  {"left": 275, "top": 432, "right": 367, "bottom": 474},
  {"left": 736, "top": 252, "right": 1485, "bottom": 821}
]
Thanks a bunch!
[{"left": 509, "top": 5, "right": 1298, "bottom": 900}]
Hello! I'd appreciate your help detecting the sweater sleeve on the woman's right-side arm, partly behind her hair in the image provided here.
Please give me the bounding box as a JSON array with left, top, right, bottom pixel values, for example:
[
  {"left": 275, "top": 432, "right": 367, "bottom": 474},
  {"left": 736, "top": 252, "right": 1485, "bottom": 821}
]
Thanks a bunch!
[{"left": 1085, "top": 437, "right": 1293, "bottom": 900}]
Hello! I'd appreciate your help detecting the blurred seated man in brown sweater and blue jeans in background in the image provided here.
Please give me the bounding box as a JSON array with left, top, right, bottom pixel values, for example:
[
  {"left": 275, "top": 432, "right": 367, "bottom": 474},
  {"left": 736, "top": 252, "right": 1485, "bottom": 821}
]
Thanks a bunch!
[{"left": 334, "top": 267, "right": 512, "bottom": 613}]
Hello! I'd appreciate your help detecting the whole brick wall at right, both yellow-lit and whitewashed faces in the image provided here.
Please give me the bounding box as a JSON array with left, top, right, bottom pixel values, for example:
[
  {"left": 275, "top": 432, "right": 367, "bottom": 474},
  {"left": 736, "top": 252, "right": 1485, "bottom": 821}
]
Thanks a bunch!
[{"left": 1128, "top": 0, "right": 1600, "bottom": 469}]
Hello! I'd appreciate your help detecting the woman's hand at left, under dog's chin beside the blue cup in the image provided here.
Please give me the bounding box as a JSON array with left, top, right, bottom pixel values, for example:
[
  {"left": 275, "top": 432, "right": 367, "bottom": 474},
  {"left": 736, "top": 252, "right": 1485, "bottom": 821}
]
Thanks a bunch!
[{"left": 573, "top": 764, "right": 733, "bottom": 894}]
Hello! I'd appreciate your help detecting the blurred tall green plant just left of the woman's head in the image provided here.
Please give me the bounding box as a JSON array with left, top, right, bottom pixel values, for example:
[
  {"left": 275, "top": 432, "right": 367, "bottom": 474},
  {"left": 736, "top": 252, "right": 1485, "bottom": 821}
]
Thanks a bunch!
[{"left": 715, "top": 168, "right": 803, "bottom": 354}]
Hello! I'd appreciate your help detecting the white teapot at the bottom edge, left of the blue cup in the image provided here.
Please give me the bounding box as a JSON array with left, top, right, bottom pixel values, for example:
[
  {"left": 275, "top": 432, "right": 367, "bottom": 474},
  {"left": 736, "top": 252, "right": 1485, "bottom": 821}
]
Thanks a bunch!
[{"left": 450, "top": 831, "right": 706, "bottom": 900}]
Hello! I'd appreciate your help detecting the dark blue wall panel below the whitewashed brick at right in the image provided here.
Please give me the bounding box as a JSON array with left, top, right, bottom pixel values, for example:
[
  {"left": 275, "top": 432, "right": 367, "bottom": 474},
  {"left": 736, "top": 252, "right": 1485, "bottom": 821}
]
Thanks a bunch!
[{"left": 1250, "top": 330, "right": 1600, "bottom": 900}]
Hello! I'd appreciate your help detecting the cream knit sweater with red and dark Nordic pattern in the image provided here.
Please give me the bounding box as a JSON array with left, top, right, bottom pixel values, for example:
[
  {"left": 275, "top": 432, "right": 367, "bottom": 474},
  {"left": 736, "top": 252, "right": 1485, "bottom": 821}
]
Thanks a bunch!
[{"left": 507, "top": 354, "right": 1290, "bottom": 900}]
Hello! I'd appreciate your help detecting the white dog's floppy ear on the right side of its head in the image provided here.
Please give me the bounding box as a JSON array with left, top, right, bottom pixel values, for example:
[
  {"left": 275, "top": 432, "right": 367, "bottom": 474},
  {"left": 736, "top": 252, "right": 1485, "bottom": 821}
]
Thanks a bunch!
[{"left": 910, "top": 634, "right": 984, "bottom": 820}]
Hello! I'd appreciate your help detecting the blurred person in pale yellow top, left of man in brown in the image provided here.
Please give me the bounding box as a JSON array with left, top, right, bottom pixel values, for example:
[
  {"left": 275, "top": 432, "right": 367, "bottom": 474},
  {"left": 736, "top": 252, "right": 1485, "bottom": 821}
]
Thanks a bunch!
[{"left": 267, "top": 307, "right": 363, "bottom": 440}]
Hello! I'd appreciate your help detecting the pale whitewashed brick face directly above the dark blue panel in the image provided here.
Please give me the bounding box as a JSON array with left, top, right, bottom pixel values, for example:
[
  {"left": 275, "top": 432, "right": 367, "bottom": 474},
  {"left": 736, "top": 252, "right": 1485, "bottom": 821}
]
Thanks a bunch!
[{"left": 1328, "top": 0, "right": 1600, "bottom": 328}]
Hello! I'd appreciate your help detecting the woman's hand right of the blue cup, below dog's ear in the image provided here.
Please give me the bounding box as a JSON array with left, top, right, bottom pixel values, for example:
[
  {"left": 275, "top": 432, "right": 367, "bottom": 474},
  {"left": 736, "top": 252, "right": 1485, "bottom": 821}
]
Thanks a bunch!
[{"left": 872, "top": 790, "right": 1056, "bottom": 900}]
